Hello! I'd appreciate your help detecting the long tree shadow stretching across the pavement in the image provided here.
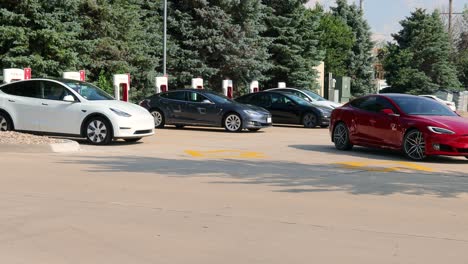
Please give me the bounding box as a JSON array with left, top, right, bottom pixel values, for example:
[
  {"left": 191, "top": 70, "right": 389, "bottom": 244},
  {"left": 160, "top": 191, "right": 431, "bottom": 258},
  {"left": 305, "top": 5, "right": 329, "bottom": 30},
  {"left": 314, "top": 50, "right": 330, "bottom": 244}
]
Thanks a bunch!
[{"left": 63, "top": 156, "right": 468, "bottom": 197}]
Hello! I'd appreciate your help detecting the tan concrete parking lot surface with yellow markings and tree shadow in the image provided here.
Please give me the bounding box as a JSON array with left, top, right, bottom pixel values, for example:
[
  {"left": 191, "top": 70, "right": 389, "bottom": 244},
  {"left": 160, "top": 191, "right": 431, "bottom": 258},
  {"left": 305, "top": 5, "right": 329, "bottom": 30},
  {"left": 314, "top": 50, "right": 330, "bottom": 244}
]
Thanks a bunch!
[{"left": 0, "top": 126, "right": 468, "bottom": 264}]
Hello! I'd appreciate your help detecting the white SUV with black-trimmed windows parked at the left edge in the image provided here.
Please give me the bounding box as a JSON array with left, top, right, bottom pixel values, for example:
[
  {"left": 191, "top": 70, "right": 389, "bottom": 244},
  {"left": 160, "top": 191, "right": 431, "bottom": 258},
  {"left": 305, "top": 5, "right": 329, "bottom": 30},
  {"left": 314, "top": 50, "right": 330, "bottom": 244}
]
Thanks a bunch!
[{"left": 0, "top": 79, "right": 154, "bottom": 145}]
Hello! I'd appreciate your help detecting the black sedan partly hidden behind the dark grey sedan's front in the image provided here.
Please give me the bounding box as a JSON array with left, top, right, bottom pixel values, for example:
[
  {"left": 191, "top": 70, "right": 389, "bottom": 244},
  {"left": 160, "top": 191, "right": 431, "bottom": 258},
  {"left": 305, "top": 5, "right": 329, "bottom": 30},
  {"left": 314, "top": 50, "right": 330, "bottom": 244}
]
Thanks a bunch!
[{"left": 235, "top": 91, "right": 331, "bottom": 128}]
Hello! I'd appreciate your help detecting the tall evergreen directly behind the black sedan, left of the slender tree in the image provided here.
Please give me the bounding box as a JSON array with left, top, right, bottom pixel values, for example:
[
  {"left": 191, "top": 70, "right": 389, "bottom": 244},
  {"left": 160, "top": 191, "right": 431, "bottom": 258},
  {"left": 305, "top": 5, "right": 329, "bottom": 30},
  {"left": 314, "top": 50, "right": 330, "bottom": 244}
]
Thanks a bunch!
[{"left": 263, "top": 0, "right": 323, "bottom": 89}]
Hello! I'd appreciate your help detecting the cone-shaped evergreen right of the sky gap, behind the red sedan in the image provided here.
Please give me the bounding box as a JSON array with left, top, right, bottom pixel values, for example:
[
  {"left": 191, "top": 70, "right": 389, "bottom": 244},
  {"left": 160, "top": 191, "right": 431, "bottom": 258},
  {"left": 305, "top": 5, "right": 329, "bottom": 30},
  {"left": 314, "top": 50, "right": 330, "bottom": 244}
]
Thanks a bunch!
[{"left": 383, "top": 9, "right": 460, "bottom": 94}]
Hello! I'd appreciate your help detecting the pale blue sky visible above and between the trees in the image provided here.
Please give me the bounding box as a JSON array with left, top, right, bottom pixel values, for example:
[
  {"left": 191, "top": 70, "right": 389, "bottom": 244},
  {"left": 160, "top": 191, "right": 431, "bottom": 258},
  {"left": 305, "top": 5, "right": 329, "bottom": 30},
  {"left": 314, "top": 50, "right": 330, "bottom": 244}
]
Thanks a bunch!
[{"left": 307, "top": 0, "right": 468, "bottom": 41}]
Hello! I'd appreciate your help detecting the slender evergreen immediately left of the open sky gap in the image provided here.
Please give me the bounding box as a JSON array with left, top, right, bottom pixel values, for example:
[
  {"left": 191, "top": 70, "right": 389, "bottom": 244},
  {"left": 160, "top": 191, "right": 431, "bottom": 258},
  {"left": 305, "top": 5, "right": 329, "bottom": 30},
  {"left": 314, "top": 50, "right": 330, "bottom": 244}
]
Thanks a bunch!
[{"left": 332, "top": 0, "right": 375, "bottom": 95}]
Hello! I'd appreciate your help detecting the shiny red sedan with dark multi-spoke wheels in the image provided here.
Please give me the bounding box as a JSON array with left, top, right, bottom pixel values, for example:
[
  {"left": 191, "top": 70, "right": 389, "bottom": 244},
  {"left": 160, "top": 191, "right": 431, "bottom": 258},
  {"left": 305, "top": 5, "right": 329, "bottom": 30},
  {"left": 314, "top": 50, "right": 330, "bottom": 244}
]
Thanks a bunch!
[{"left": 330, "top": 94, "right": 468, "bottom": 160}]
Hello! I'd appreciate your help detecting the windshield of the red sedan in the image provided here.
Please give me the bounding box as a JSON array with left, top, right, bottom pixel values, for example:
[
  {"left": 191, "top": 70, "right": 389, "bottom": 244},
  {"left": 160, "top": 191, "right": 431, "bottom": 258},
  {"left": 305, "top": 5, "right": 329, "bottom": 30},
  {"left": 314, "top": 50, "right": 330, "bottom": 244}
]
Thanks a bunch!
[{"left": 392, "top": 97, "right": 457, "bottom": 116}]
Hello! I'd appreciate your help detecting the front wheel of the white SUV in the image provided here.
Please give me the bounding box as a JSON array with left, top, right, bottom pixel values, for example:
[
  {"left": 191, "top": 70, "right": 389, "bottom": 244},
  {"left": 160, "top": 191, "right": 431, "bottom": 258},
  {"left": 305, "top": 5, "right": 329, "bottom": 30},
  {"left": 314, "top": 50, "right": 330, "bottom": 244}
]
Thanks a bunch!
[{"left": 85, "top": 116, "right": 113, "bottom": 145}]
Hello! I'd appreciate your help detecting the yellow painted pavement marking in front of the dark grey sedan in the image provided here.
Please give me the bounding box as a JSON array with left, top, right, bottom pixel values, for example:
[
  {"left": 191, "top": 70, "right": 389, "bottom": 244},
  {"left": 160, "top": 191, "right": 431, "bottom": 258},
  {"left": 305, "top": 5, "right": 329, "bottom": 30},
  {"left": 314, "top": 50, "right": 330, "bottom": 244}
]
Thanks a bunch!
[{"left": 185, "top": 149, "right": 266, "bottom": 159}]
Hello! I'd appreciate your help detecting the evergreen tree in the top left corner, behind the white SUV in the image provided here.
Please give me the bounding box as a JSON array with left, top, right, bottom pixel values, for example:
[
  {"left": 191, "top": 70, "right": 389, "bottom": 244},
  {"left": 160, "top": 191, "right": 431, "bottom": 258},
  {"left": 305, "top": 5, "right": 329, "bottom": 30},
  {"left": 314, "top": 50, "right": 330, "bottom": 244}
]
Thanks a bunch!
[{"left": 0, "top": 0, "right": 80, "bottom": 77}]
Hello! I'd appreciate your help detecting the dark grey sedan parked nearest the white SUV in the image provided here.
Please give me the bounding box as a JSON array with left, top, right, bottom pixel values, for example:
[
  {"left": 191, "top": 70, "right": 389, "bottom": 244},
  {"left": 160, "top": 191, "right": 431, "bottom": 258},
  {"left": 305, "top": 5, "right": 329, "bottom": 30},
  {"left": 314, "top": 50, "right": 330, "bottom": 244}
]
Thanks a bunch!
[{"left": 140, "top": 89, "right": 271, "bottom": 132}]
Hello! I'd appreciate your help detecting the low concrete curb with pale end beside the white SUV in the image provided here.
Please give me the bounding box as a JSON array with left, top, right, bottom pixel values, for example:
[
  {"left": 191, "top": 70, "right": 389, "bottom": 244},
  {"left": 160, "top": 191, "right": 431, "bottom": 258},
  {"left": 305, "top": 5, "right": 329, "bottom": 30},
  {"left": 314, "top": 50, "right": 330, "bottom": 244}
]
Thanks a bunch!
[{"left": 0, "top": 140, "right": 80, "bottom": 153}]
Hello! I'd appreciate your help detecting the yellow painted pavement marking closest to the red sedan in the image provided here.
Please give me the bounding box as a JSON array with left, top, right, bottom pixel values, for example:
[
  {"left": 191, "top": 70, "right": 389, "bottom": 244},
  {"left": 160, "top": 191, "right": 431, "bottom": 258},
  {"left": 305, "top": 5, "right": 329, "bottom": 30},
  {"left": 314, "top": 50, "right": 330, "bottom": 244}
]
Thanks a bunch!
[{"left": 335, "top": 161, "right": 434, "bottom": 172}]
